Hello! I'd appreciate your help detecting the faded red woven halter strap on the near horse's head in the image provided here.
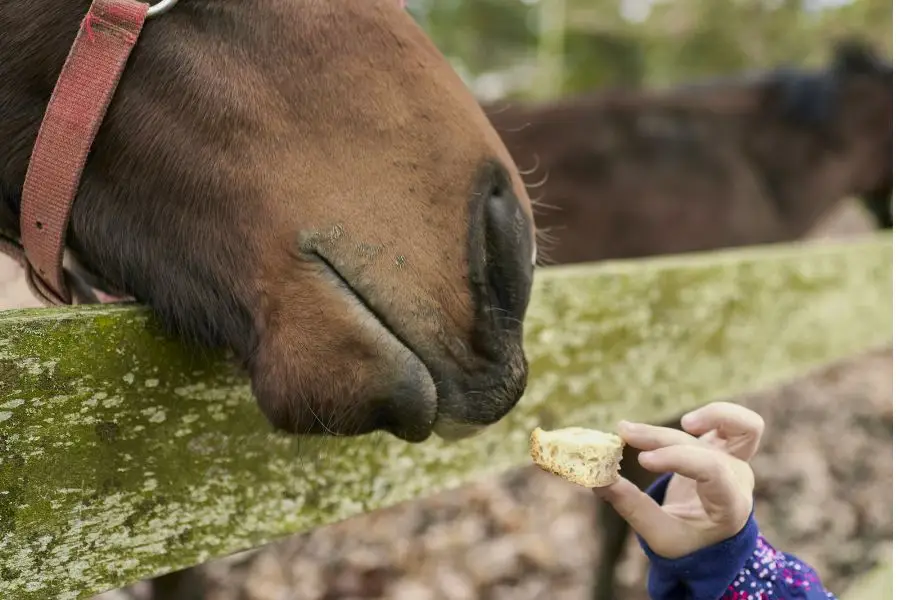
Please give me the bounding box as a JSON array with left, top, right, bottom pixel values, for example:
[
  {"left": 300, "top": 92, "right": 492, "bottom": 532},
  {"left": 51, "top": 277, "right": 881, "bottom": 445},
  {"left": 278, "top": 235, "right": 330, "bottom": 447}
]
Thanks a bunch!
[{"left": 14, "top": 0, "right": 148, "bottom": 304}]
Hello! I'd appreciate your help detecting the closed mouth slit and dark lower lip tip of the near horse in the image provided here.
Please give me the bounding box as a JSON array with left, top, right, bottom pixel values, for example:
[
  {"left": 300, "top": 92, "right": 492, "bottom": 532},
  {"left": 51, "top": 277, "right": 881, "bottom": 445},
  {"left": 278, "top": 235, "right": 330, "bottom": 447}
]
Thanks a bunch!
[{"left": 308, "top": 251, "right": 438, "bottom": 442}]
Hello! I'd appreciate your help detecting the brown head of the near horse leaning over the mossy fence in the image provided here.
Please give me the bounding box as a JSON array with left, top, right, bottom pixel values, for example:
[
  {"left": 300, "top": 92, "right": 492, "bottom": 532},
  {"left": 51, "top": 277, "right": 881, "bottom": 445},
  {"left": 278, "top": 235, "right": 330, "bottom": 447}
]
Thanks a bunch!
[{"left": 0, "top": 0, "right": 535, "bottom": 600}]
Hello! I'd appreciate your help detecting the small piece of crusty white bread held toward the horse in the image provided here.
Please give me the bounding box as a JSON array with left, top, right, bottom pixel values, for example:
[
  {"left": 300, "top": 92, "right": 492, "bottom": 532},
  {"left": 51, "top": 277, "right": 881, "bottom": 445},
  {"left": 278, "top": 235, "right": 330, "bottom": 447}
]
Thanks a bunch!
[{"left": 531, "top": 427, "right": 625, "bottom": 488}]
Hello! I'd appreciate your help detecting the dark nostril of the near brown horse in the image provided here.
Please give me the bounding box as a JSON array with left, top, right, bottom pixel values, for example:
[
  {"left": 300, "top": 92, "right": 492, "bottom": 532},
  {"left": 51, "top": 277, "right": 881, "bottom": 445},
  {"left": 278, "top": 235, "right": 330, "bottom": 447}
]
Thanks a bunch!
[{"left": 484, "top": 186, "right": 533, "bottom": 329}]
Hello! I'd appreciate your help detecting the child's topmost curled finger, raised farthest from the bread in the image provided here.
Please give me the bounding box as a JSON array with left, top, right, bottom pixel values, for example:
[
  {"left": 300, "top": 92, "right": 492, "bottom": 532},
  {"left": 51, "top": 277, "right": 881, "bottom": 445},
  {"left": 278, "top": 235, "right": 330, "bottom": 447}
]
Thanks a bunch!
[{"left": 681, "top": 402, "right": 766, "bottom": 461}]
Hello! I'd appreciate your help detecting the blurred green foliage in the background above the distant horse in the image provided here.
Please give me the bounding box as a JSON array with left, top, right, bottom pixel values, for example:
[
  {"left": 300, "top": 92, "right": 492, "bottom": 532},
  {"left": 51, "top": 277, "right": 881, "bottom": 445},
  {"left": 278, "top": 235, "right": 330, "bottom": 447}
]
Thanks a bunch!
[{"left": 410, "top": 0, "right": 892, "bottom": 98}]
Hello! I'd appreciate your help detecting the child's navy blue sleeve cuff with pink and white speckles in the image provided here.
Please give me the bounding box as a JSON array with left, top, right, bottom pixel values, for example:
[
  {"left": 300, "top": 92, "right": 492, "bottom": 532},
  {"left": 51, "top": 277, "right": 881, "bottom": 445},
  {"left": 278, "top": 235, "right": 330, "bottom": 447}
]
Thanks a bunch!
[{"left": 638, "top": 473, "right": 835, "bottom": 600}]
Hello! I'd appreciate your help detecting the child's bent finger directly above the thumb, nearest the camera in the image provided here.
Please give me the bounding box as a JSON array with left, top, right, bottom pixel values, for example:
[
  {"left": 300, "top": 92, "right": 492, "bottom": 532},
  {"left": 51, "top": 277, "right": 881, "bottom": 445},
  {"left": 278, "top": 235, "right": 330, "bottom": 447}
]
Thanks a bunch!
[{"left": 638, "top": 445, "right": 747, "bottom": 523}]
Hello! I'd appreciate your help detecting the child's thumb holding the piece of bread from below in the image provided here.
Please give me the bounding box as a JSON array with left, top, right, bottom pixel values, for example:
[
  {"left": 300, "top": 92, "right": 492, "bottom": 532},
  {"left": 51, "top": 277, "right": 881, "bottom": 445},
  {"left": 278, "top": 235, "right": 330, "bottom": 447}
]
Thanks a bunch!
[{"left": 594, "top": 477, "right": 678, "bottom": 548}]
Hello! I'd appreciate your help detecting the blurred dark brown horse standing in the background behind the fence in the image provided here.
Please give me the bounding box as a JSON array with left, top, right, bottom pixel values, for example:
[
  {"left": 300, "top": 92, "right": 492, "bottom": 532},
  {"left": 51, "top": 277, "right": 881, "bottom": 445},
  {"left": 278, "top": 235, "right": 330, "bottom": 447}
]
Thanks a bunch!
[{"left": 486, "top": 42, "right": 893, "bottom": 600}]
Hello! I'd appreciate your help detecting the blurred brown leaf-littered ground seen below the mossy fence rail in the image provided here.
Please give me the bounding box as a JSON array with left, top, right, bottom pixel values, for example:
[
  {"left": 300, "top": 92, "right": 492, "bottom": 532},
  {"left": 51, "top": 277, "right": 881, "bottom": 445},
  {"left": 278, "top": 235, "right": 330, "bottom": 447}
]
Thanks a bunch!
[{"left": 0, "top": 202, "right": 893, "bottom": 600}]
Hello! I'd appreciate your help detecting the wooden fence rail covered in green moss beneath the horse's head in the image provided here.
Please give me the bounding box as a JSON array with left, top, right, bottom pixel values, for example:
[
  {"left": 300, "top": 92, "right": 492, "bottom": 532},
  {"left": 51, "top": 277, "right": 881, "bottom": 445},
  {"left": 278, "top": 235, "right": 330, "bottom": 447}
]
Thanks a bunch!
[{"left": 0, "top": 235, "right": 892, "bottom": 600}]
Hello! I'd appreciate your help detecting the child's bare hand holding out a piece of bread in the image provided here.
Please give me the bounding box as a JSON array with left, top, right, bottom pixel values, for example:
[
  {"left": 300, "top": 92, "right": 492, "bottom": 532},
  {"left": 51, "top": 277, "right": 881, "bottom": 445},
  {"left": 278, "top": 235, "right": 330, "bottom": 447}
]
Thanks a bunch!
[{"left": 594, "top": 402, "right": 765, "bottom": 558}]
